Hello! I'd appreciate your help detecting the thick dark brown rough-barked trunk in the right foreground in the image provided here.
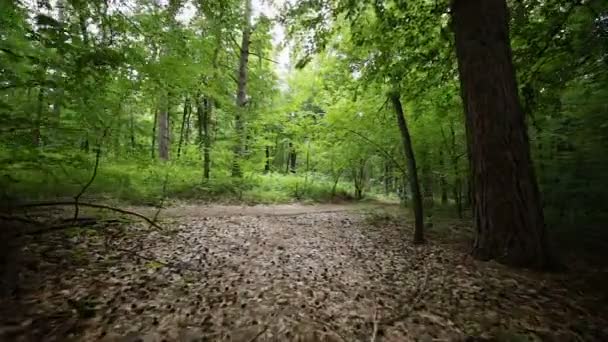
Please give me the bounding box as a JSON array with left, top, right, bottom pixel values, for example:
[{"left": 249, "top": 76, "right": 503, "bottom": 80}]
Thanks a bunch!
[{"left": 452, "top": 0, "right": 549, "bottom": 267}]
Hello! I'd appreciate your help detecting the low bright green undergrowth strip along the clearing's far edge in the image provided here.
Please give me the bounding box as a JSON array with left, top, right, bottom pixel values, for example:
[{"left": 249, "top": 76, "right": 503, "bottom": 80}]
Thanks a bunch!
[{"left": 0, "top": 159, "right": 352, "bottom": 204}]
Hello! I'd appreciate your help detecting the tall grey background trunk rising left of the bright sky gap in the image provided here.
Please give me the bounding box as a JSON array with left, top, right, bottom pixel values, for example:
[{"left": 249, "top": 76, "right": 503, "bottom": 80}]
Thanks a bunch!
[{"left": 232, "top": 0, "right": 251, "bottom": 177}]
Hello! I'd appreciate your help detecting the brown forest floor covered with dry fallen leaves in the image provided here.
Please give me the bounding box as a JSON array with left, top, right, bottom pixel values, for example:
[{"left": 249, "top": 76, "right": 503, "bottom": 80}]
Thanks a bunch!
[{"left": 0, "top": 204, "right": 608, "bottom": 342}]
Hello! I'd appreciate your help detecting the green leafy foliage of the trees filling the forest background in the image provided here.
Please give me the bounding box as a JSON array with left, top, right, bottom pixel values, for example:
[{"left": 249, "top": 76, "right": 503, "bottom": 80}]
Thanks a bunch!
[{"left": 0, "top": 0, "right": 608, "bottom": 243}]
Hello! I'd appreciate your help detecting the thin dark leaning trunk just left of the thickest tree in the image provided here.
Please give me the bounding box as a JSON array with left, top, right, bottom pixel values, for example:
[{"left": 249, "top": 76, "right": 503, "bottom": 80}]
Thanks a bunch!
[{"left": 390, "top": 92, "right": 424, "bottom": 244}]
